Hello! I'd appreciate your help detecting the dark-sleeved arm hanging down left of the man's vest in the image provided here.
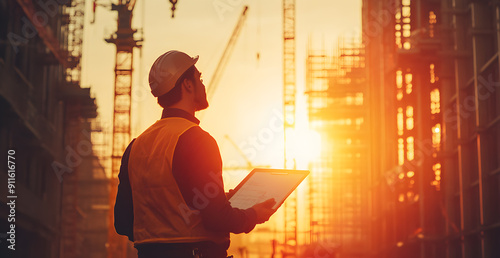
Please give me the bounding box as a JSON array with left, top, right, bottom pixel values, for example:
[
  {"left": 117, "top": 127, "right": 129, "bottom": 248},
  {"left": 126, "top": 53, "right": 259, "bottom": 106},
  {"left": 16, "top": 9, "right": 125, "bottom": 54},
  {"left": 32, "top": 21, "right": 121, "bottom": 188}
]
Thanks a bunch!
[{"left": 114, "top": 139, "right": 135, "bottom": 242}]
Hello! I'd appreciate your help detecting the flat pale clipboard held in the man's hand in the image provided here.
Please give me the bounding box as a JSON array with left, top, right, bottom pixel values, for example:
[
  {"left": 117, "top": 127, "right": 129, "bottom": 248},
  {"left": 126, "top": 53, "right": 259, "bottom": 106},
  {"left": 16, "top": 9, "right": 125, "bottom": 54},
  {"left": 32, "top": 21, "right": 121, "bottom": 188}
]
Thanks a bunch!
[{"left": 228, "top": 168, "right": 309, "bottom": 209}]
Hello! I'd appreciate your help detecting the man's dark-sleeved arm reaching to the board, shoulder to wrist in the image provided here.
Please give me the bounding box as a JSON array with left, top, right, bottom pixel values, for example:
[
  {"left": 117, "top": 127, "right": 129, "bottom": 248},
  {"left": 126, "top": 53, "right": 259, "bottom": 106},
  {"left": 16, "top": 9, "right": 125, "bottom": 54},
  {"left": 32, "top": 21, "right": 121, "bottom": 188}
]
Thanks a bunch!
[{"left": 172, "top": 127, "right": 258, "bottom": 233}]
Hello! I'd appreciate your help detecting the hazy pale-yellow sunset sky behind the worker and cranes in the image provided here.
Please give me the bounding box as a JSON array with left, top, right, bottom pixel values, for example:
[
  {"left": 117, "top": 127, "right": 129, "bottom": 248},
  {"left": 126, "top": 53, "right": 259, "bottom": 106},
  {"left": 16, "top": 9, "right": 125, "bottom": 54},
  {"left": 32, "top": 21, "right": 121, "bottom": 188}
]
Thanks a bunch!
[{"left": 82, "top": 0, "right": 361, "bottom": 185}]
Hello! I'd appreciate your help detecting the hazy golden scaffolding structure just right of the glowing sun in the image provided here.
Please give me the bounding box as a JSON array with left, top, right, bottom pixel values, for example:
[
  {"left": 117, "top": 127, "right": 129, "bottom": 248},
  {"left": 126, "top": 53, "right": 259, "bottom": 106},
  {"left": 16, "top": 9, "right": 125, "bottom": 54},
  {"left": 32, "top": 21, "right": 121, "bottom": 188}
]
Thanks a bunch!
[{"left": 306, "top": 39, "right": 369, "bottom": 257}]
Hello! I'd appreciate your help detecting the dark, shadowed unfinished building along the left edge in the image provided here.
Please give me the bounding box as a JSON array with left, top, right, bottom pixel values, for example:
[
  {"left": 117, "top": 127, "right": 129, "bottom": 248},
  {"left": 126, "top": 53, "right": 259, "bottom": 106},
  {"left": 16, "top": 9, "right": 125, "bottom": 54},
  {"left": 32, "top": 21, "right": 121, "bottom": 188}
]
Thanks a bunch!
[{"left": 0, "top": 0, "right": 109, "bottom": 258}]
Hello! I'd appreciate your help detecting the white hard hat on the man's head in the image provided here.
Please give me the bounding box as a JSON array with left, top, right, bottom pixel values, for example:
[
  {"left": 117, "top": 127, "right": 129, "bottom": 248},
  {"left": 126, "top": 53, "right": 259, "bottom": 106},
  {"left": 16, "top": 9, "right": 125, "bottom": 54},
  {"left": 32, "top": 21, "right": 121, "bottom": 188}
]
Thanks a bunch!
[{"left": 149, "top": 50, "right": 198, "bottom": 97}]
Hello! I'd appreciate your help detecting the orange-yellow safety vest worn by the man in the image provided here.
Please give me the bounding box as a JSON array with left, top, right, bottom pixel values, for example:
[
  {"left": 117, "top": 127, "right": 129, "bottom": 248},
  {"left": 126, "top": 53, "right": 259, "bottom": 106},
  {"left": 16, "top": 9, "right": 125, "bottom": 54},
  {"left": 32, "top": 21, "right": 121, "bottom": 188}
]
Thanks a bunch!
[{"left": 128, "top": 117, "right": 228, "bottom": 244}]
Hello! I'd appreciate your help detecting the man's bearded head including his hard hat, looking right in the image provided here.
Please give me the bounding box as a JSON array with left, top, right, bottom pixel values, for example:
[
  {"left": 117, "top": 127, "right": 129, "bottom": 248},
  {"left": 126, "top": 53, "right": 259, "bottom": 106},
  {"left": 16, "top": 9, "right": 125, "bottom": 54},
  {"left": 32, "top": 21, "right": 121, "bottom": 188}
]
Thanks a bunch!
[{"left": 149, "top": 50, "right": 208, "bottom": 111}]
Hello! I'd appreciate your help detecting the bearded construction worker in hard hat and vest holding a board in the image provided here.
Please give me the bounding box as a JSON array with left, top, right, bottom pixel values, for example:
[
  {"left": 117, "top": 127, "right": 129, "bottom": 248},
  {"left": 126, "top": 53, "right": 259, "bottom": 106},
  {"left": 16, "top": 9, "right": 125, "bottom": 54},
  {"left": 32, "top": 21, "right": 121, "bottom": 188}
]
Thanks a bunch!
[{"left": 114, "top": 51, "right": 275, "bottom": 258}]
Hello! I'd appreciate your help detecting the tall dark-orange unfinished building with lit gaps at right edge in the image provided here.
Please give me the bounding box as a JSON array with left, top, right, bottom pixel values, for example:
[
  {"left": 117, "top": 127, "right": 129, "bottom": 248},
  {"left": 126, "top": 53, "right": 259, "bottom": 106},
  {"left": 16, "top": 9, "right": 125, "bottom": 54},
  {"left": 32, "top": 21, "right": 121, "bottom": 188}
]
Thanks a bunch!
[{"left": 363, "top": 0, "right": 500, "bottom": 258}]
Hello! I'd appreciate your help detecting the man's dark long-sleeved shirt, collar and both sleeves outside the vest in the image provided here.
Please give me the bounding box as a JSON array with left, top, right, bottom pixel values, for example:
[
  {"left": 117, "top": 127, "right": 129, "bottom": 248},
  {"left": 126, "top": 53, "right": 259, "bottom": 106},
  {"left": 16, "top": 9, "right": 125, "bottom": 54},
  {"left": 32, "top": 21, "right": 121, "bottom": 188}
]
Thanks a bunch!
[{"left": 115, "top": 108, "right": 257, "bottom": 241}]
